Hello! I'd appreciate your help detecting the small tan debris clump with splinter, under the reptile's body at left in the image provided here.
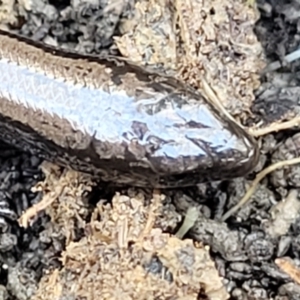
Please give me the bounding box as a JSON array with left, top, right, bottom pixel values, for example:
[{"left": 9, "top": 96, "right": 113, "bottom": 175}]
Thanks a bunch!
[{"left": 19, "top": 162, "right": 95, "bottom": 245}]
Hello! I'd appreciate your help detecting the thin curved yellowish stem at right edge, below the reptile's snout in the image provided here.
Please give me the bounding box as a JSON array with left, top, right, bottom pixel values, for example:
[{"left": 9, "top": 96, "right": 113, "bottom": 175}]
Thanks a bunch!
[{"left": 222, "top": 157, "right": 300, "bottom": 221}]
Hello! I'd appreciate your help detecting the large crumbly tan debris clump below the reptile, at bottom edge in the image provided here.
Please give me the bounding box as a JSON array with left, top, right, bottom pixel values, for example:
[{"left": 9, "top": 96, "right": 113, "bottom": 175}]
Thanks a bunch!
[{"left": 33, "top": 188, "right": 229, "bottom": 300}]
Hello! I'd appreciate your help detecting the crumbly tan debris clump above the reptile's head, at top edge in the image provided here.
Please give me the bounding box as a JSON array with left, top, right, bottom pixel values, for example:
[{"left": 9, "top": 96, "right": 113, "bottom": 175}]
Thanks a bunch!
[{"left": 115, "top": 0, "right": 265, "bottom": 120}]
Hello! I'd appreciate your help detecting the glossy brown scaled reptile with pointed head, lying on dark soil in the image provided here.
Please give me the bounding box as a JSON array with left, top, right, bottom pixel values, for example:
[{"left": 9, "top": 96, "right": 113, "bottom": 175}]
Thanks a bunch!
[{"left": 0, "top": 31, "right": 258, "bottom": 188}]
